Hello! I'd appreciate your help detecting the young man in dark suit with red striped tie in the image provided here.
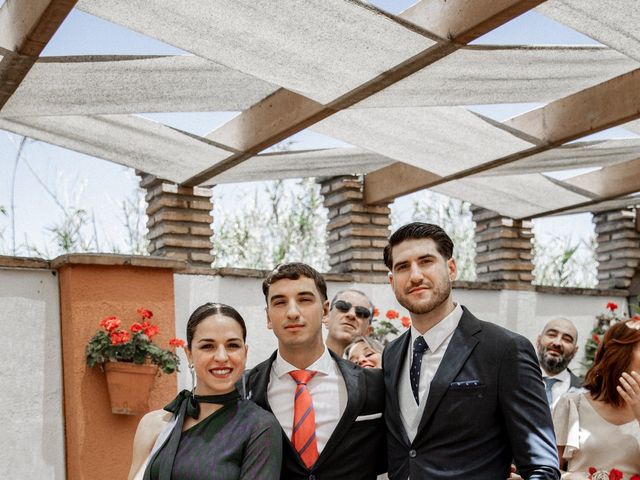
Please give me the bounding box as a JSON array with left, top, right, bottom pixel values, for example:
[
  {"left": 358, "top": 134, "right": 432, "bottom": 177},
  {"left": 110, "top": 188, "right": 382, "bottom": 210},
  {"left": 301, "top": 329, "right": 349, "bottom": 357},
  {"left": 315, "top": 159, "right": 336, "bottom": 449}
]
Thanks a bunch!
[{"left": 246, "top": 263, "right": 386, "bottom": 480}]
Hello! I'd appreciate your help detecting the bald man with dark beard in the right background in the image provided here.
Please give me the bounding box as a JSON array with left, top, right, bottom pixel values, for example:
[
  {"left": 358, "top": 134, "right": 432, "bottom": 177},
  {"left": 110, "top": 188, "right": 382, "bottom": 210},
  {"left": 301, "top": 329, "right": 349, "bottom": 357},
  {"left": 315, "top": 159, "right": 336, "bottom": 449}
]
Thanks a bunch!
[{"left": 537, "top": 318, "right": 582, "bottom": 410}]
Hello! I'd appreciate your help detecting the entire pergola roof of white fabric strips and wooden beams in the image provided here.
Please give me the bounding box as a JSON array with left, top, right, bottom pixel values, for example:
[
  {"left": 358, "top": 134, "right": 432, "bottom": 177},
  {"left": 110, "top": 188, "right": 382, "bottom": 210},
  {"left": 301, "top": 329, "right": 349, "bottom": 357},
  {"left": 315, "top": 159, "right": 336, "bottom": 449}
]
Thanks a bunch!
[{"left": 0, "top": 0, "right": 640, "bottom": 218}]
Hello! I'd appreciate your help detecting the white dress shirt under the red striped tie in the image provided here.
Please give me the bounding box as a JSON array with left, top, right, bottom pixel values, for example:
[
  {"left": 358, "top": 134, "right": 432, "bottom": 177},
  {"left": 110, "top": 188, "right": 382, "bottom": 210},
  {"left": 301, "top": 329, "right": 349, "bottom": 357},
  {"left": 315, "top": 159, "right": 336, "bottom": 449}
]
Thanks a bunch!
[{"left": 267, "top": 346, "right": 347, "bottom": 454}]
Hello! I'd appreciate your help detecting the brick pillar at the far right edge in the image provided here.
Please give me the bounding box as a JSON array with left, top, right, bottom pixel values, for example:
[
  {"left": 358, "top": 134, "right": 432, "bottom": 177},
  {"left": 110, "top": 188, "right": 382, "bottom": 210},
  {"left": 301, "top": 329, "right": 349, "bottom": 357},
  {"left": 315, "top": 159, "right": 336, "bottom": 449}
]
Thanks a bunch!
[{"left": 593, "top": 208, "right": 640, "bottom": 289}]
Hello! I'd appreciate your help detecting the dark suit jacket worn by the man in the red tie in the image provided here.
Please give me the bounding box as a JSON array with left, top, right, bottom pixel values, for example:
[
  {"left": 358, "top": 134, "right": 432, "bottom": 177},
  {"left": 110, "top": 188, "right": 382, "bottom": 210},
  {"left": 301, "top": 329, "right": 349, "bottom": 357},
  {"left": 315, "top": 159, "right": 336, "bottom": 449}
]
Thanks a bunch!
[{"left": 246, "top": 351, "right": 387, "bottom": 480}]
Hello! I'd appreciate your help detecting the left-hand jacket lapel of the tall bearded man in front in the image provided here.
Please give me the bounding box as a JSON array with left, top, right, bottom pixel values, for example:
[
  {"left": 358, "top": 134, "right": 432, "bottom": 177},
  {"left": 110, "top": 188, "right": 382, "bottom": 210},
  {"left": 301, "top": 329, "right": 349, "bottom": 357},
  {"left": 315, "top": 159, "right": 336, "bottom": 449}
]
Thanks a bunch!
[{"left": 383, "top": 330, "right": 411, "bottom": 445}]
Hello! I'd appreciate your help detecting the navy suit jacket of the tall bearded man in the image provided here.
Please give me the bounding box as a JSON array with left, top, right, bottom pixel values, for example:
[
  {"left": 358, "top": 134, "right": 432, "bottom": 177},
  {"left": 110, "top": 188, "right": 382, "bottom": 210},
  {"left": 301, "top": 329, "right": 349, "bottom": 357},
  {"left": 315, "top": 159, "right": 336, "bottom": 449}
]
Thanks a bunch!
[{"left": 383, "top": 307, "right": 560, "bottom": 480}]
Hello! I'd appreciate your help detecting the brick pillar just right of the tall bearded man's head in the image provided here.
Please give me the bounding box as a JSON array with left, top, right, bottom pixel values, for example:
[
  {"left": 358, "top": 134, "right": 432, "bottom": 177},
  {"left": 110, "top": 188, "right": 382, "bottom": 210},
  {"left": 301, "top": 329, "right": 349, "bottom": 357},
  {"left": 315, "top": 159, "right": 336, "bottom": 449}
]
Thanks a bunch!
[{"left": 471, "top": 206, "right": 533, "bottom": 285}]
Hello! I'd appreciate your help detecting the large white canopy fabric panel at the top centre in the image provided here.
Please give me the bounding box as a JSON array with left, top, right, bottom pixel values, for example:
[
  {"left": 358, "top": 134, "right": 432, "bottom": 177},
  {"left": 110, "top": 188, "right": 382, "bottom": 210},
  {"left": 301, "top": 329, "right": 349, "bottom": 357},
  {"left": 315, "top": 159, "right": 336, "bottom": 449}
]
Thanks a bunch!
[{"left": 78, "top": 0, "right": 434, "bottom": 103}]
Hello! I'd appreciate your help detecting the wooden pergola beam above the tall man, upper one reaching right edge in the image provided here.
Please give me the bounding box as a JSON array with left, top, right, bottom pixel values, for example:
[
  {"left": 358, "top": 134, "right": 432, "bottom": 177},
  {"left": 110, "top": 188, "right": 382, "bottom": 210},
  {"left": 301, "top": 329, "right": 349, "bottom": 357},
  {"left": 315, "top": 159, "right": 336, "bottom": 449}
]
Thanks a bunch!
[{"left": 364, "top": 69, "right": 640, "bottom": 204}]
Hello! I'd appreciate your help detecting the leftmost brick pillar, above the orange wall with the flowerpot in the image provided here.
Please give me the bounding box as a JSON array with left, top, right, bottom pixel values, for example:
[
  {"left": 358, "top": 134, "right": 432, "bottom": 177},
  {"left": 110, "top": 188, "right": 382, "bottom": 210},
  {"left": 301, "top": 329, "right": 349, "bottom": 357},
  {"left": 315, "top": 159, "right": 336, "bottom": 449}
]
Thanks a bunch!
[{"left": 140, "top": 173, "right": 213, "bottom": 268}]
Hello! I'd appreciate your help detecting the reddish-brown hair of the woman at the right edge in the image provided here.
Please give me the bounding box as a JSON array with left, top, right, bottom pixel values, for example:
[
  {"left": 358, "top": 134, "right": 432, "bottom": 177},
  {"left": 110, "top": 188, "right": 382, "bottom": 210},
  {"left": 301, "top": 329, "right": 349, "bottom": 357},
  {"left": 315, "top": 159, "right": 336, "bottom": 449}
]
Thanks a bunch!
[{"left": 583, "top": 320, "right": 640, "bottom": 407}]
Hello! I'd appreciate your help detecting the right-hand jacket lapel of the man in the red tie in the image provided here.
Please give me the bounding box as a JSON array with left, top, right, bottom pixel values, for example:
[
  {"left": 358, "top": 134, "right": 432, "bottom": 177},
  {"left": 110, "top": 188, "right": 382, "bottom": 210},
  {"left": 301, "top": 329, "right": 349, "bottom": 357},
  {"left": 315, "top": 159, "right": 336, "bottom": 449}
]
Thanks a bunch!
[{"left": 314, "top": 350, "right": 367, "bottom": 469}]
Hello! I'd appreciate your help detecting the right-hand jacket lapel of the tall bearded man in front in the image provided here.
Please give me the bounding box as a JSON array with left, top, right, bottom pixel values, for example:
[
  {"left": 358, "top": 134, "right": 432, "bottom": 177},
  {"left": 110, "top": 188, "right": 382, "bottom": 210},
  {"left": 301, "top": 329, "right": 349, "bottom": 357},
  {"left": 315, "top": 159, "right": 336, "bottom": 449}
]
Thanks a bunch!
[{"left": 416, "top": 307, "right": 481, "bottom": 439}]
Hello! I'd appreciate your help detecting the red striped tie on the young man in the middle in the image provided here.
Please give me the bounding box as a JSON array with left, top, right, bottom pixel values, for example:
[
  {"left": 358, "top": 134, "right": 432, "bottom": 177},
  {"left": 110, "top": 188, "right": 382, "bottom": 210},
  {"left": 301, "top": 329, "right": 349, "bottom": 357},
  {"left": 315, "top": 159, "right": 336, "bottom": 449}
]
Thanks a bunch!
[{"left": 289, "top": 370, "right": 318, "bottom": 468}]
